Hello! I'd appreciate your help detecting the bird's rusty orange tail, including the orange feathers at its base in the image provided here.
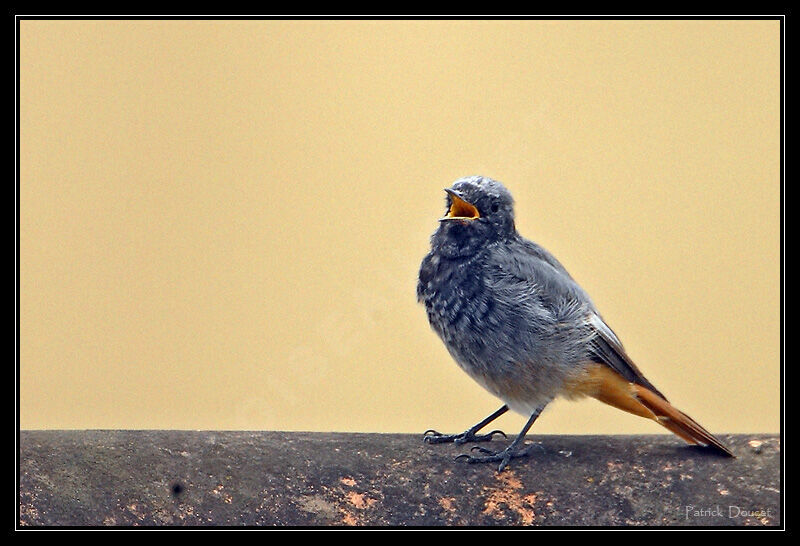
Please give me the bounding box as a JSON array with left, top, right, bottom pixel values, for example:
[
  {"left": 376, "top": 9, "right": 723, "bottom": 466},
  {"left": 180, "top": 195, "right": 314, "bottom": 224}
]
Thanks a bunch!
[{"left": 567, "top": 364, "right": 734, "bottom": 457}]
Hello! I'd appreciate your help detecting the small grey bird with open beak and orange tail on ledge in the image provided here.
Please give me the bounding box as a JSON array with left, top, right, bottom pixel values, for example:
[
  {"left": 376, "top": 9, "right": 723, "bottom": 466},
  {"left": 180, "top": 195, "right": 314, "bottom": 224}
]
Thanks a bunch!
[{"left": 417, "top": 176, "right": 734, "bottom": 472}]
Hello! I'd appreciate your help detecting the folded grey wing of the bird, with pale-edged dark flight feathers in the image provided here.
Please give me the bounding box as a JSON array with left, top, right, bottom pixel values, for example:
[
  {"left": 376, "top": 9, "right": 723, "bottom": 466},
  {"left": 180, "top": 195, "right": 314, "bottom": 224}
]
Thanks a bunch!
[{"left": 492, "top": 239, "right": 666, "bottom": 400}]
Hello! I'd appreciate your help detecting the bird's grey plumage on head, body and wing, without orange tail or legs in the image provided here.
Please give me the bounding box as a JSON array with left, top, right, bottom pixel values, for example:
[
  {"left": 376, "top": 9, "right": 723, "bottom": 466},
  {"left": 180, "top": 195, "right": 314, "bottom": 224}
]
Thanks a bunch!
[{"left": 417, "top": 176, "right": 660, "bottom": 415}]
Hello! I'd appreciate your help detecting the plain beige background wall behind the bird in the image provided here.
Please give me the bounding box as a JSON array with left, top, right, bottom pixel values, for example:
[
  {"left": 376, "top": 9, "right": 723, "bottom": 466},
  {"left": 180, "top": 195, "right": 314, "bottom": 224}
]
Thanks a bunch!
[{"left": 20, "top": 21, "right": 780, "bottom": 433}]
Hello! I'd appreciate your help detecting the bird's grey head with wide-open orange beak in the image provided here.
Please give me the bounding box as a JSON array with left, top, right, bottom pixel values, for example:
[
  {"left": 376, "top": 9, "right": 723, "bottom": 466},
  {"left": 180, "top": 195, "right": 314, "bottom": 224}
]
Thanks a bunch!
[{"left": 432, "top": 176, "right": 516, "bottom": 256}]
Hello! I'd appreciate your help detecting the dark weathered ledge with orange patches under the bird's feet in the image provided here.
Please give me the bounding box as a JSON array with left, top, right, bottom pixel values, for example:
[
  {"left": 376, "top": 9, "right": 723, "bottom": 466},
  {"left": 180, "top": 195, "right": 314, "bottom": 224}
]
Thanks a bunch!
[{"left": 19, "top": 430, "right": 782, "bottom": 527}]
